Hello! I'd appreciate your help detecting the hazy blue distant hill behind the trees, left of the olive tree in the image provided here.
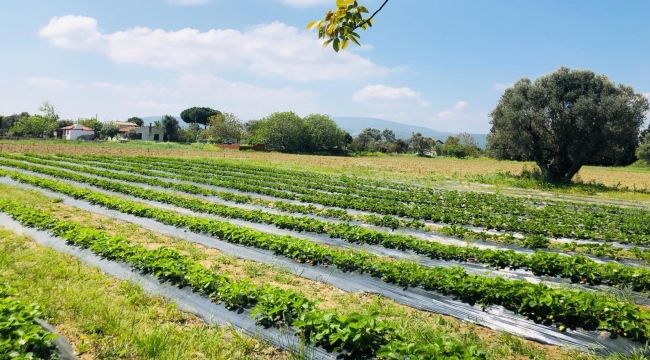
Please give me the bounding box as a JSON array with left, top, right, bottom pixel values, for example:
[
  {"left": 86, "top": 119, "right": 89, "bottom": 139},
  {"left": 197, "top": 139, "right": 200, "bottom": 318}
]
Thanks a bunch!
[{"left": 334, "top": 116, "right": 487, "bottom": 148}]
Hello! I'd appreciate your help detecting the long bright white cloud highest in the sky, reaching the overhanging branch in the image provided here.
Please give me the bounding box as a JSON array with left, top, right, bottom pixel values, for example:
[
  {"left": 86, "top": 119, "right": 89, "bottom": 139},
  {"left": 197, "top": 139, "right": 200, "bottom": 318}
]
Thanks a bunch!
[{"left": 39, "top": 15, "right": 389, "bottom": 81}]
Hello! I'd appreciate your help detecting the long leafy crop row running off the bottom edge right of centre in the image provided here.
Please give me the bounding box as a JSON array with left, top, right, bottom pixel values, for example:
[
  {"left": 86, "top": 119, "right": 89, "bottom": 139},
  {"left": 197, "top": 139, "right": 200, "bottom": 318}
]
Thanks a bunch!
[{"left": 0, "top": 199, "right": 486, "bottom": 358}]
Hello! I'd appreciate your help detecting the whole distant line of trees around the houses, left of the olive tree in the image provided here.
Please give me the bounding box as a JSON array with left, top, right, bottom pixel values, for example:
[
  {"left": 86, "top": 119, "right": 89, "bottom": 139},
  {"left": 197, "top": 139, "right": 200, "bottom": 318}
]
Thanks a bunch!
[{"left": 0, "top": 102, "right": 481, "bottom": 157}]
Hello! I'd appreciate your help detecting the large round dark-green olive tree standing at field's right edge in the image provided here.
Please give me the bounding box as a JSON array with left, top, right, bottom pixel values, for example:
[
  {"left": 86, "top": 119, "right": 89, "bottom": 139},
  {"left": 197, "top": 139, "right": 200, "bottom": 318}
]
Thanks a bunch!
[{"left": 488, "top": 68, "right": 649, "bottom": 182}]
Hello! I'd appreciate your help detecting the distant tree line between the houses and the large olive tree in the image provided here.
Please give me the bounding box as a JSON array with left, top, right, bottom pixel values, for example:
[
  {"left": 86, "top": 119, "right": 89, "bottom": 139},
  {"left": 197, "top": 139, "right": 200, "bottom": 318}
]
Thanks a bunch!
[{"left": 171, "top": 107, "right": 481, "bottom": 158}]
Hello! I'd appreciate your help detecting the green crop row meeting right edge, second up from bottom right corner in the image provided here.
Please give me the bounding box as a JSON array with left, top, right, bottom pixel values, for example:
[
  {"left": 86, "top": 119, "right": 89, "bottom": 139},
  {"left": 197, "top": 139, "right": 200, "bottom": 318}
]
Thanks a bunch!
[{"left": 0, "top": 159, "right": 650, "bottom": 291}]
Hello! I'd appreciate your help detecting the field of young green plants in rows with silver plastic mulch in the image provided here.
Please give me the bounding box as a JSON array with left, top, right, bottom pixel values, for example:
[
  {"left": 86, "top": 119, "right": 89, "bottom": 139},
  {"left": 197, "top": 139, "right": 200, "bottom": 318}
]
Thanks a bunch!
[{"left": 0, "top": 153, "right": 650, "bottom": 359}]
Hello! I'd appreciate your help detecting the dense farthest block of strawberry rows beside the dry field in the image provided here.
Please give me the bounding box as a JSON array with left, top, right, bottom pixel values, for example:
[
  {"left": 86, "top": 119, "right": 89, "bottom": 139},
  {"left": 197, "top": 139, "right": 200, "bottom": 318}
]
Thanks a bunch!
[{"left": 40, "top": 152, "right": 650, "bottom": 245}]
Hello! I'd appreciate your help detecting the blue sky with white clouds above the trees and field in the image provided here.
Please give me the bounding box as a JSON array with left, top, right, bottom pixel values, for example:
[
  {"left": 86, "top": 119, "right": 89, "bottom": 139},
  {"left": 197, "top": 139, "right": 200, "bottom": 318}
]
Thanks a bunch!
[{"left": 0, "top": 0, "right": 650, "bottom": 132}]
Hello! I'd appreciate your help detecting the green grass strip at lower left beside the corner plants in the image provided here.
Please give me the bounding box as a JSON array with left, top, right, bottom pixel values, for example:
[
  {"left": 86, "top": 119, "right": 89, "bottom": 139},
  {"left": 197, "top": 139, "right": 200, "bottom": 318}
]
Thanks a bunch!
[{"left": 0, "top": 229, "right": 286, "bottom": 359}]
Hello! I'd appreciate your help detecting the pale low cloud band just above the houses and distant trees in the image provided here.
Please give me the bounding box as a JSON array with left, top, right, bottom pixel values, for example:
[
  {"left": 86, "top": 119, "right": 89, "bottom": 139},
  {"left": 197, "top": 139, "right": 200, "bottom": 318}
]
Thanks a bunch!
[{"left": 18, "top": 74, "right": 319, "bottom": 120}]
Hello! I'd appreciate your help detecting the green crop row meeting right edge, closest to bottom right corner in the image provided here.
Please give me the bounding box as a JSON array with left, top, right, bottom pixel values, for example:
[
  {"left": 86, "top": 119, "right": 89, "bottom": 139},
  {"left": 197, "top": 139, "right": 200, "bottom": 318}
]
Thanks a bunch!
[{"left": 0, "top": 169, "right": 650, "bottom": 341}]
